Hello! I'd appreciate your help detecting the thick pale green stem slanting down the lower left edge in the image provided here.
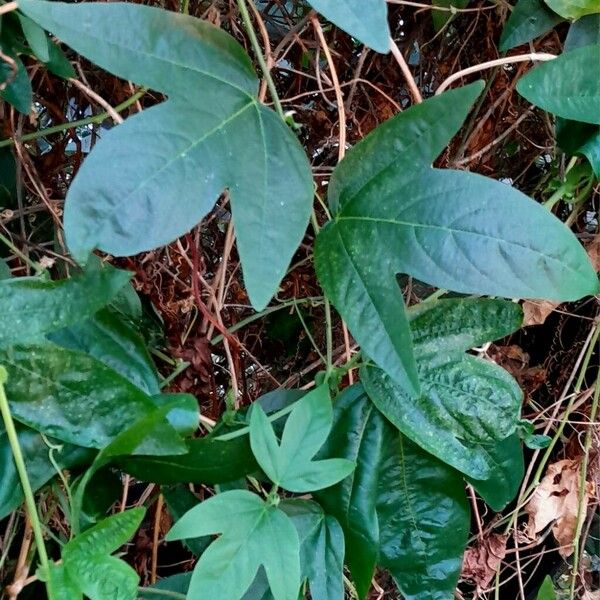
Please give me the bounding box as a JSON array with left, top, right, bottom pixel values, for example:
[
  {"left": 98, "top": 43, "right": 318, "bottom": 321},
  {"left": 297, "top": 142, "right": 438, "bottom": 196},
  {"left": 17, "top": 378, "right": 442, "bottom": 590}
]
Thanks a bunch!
[{"left": 0, "top": 366, "right": 50, "bottom": 574}]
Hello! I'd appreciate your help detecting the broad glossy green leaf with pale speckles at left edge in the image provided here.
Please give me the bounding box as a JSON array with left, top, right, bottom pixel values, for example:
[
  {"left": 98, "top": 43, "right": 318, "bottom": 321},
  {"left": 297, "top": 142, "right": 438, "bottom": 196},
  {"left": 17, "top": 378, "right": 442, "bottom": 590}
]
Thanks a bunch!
[{"left": 0, "top": 343, "right": 164, "bottom": 448}]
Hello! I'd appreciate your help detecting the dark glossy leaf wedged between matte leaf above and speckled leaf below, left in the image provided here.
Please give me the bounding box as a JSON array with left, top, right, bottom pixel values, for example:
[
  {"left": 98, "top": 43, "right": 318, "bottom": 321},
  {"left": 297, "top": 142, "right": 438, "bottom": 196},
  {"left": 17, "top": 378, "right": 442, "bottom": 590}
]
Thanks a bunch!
[{"left": 48, "top": 308, "right": 160, "bottom": 395}]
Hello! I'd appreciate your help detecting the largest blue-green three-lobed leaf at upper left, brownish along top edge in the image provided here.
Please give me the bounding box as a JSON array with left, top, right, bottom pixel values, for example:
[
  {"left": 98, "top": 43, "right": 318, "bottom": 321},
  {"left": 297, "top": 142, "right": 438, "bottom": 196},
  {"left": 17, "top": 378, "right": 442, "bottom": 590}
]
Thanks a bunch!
[{"left": 19, "top": 0, "right": 313, "bottom": 310}]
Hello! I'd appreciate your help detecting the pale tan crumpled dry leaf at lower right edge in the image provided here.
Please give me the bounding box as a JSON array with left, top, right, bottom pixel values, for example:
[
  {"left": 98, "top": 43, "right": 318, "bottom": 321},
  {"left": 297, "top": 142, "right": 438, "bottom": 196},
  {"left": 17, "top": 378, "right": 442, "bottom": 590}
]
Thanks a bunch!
[{"left": 525, "top": 460, "right": 595, "bottom": 557}]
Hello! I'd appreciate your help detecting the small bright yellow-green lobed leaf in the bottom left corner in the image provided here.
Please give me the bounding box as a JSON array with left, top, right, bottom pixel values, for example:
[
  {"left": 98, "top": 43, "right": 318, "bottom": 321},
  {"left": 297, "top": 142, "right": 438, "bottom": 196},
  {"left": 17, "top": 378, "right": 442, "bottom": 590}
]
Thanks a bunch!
[{"left": 62, "top": 508, "right": 145, "bottom": 600}]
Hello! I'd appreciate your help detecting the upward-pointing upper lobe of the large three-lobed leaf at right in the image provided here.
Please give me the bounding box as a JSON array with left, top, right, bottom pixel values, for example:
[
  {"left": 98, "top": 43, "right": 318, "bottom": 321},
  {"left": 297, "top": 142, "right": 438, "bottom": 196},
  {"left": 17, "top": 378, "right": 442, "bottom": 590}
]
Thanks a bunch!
[{"left": 327, "top": 81, "right": 484, "bottom": 213}]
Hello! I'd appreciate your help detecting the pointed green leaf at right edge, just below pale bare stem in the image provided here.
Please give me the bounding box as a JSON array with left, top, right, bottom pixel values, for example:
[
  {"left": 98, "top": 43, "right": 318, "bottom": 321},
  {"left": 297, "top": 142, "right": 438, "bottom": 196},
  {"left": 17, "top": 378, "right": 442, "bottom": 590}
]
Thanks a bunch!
[{"left": 517, "top": 44, "right": 600, "bottom": 125}]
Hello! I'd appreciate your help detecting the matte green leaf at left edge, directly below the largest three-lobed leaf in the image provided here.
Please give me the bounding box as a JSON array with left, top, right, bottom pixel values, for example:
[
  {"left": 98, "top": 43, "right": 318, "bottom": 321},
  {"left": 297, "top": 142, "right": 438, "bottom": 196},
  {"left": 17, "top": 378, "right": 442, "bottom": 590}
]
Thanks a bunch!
[{"left": 0, "top": 265, "right": 131, "bottom": 346}]
